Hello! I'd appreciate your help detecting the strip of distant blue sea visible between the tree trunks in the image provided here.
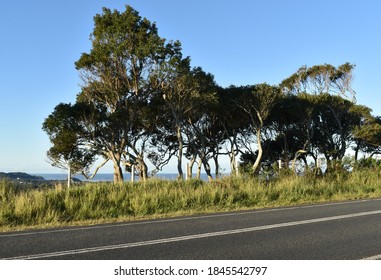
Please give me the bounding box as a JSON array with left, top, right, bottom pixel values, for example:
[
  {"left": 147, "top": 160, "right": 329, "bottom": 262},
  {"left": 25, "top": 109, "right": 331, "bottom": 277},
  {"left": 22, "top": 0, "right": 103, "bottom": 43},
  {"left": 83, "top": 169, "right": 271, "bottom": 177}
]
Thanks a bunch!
[{"left": 31, "top": 173, "right": 208, "bottom": 182}]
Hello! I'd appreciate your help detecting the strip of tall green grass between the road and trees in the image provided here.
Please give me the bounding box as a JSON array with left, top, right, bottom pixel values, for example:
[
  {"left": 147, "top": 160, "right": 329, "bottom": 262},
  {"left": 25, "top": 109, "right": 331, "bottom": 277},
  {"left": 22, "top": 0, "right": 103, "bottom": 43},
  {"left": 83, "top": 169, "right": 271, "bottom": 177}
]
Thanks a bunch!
[{"left": 0, "top": 170, "right": 381, "bottom": 231}]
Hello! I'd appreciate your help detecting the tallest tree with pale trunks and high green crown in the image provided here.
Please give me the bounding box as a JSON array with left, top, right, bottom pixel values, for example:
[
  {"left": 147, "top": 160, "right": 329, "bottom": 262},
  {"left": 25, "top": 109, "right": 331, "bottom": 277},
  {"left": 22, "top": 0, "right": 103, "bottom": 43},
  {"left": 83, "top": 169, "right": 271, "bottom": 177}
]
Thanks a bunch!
[{"left": 75, "top": 6, "right": 179, "bottom": 182}]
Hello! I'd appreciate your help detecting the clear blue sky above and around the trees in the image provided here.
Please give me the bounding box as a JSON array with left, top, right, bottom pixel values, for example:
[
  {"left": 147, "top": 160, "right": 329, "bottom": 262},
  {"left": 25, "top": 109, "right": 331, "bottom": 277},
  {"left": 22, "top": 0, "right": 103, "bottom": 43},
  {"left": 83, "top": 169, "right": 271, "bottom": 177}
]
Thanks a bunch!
[{"left": 0, "top": 0, "right": 381, "bottom": 173}]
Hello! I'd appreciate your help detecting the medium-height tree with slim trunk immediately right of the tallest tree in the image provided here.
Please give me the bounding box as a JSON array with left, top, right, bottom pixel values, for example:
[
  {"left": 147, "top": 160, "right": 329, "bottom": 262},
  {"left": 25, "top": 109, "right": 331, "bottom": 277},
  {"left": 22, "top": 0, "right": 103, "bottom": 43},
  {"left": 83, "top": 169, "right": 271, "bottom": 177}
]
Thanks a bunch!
[{"left": 151, "top": 55, "right": 216, "bottom": 180}]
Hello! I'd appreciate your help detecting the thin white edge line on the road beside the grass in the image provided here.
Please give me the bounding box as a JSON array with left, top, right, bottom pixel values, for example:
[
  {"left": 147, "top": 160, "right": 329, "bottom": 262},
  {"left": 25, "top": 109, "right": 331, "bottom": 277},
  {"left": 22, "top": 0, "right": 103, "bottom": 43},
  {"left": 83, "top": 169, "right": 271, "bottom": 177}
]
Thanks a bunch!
[{"left": 0, "top": 199, "right": 381, "bottom": 238}]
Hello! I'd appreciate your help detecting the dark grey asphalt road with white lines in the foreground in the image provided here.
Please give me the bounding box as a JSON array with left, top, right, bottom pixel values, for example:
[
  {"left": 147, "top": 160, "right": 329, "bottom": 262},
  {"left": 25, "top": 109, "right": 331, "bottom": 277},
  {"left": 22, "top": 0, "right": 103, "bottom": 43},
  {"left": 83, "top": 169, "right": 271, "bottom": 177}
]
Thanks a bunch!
[{"left": 0, "top": 199, "right": 381, "bottom": 260}]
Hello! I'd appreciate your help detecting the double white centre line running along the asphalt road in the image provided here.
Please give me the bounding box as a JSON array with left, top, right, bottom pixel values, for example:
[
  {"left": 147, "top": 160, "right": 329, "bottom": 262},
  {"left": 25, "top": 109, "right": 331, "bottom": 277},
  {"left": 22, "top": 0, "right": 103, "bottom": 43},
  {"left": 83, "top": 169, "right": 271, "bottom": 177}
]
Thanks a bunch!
[{"left": 4, "top": 210, "right": 381, "bottom": 260}]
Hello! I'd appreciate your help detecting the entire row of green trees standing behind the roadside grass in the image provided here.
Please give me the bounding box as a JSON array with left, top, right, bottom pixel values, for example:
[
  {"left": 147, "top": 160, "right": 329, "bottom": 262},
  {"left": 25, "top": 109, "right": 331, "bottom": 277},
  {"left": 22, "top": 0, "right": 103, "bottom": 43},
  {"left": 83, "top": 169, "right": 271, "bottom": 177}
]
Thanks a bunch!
[{"left": 43, "top": 6, "right": 381, "bottom": 182}]
